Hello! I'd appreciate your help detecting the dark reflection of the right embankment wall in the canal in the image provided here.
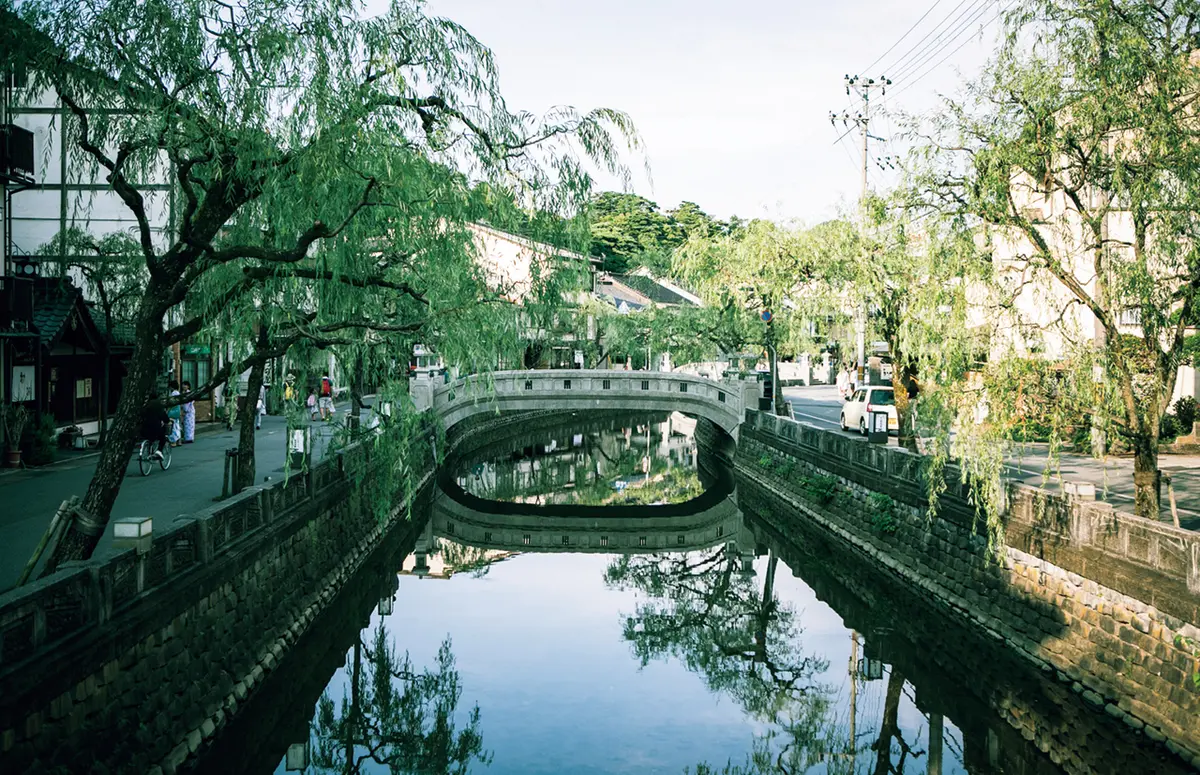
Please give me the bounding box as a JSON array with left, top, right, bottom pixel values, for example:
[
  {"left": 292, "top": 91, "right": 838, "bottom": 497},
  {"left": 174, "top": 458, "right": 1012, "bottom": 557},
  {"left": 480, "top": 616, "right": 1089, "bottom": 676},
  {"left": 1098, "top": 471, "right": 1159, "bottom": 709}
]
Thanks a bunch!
[{"left": 738, "top": 477, "right": 1194, "bottom": 775}]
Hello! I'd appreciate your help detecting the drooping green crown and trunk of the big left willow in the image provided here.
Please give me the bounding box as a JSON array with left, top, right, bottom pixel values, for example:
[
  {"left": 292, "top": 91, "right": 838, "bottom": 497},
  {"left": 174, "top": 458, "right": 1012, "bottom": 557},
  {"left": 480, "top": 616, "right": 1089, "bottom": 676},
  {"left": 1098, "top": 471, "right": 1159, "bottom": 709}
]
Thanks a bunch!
[{"left": 11, "top": 0, "right": 640, "bottom": 539}]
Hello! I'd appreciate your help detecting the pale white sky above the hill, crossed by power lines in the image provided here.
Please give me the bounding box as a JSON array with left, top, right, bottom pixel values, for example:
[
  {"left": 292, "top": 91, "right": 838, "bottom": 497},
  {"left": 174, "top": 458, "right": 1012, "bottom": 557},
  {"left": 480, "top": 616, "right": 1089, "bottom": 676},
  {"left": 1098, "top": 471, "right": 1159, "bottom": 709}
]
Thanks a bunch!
[{"left": 410, "top": 0, "right": 1008, "bottom": 223}]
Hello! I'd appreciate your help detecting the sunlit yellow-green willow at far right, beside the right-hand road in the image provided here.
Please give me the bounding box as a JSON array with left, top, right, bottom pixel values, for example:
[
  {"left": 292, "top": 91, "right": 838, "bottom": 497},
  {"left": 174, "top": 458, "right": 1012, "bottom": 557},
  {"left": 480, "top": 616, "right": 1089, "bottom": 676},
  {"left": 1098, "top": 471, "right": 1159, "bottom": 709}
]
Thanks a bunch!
[{"left": 926, "top": 0, "right": 1200, "bottom": 519}]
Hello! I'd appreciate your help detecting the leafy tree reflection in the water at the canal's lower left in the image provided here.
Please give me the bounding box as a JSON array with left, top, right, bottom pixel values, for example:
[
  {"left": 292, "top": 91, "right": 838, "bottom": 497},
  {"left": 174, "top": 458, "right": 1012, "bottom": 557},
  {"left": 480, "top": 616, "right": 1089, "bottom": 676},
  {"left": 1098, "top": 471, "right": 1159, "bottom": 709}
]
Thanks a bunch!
[{"left": 312, "top": 624, "right": 492, "bottom": 775}]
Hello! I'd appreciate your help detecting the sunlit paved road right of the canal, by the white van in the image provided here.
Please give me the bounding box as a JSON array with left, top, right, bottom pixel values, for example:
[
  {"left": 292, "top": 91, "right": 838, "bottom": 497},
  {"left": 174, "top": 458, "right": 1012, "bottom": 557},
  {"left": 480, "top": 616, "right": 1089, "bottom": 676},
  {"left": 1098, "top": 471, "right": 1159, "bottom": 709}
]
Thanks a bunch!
[{"left": 784, "top": 385, "right": 1200, "bottom": 530}]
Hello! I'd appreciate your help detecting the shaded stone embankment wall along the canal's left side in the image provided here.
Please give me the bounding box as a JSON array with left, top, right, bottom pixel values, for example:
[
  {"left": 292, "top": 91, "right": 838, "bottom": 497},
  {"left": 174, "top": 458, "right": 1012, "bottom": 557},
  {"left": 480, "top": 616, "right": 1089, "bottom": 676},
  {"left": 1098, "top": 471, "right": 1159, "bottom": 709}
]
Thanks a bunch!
[{"left": 0, "top": 431, "right": 433, "bottom": 773}]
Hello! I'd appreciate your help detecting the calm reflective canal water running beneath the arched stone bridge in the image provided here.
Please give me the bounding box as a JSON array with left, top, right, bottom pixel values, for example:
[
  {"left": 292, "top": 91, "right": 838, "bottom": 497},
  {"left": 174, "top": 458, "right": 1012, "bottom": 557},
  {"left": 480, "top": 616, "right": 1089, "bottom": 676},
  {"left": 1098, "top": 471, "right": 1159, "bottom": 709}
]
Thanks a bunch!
[{"left": 192, "top": 413, "right": 1190, "bottom": 775}]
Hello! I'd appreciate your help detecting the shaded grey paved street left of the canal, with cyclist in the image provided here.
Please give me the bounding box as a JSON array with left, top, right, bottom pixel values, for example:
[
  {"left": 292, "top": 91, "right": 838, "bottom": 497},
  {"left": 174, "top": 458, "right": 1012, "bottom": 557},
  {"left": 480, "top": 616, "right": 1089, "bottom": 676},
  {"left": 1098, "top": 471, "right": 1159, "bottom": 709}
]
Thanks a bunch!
[{"left": 0, "top": 405, "right": 369, "bottom": 590}]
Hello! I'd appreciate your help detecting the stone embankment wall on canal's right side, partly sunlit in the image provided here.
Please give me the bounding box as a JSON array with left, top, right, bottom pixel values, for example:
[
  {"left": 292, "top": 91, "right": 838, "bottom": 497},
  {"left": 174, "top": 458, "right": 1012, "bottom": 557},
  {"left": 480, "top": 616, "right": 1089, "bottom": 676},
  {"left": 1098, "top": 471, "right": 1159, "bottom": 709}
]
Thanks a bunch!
[{"left": 737, "top": 413, "right": 1200, "bottom": 768}]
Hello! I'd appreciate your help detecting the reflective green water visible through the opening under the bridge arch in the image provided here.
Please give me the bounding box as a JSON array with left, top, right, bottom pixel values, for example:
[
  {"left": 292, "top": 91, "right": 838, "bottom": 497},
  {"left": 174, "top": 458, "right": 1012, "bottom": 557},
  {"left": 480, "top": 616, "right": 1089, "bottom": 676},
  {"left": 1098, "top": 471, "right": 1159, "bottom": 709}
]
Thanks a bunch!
[{"left": 457, "top": 413, "right": 703, "bottom": 505}]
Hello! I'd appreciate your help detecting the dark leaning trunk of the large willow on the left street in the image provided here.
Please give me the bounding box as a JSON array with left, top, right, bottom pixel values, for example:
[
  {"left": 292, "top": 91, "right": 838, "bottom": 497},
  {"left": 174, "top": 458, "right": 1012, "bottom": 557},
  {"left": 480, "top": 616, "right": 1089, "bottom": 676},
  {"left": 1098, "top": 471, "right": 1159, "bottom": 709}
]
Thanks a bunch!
[{"left": 42, "top": 287, "right": 166, "bottom": 577}]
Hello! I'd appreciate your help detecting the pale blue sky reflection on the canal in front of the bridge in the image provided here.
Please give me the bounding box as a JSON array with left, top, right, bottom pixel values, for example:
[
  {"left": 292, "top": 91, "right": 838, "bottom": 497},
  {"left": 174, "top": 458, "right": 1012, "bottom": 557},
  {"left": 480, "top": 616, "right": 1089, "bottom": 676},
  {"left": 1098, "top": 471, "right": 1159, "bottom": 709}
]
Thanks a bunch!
[{"left": 288, "top": 554, "right": 964, "bottom": 774}]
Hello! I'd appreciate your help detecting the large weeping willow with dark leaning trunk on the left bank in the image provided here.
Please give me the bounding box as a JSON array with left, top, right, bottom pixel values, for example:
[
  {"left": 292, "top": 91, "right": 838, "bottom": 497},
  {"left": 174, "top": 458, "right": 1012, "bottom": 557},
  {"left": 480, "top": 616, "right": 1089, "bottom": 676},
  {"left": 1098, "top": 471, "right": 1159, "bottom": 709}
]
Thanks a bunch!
[{"left": 7, "top": 0, "right": 637, "bottom": 570}]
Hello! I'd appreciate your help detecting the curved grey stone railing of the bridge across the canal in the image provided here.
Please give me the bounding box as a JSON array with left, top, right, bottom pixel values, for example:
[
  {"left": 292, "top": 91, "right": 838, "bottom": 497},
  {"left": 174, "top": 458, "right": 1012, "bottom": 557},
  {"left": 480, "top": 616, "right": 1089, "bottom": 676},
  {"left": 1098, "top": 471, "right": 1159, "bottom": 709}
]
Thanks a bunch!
[{"left": 410, "top": 370, "right": 761, "bottom": 438}]
